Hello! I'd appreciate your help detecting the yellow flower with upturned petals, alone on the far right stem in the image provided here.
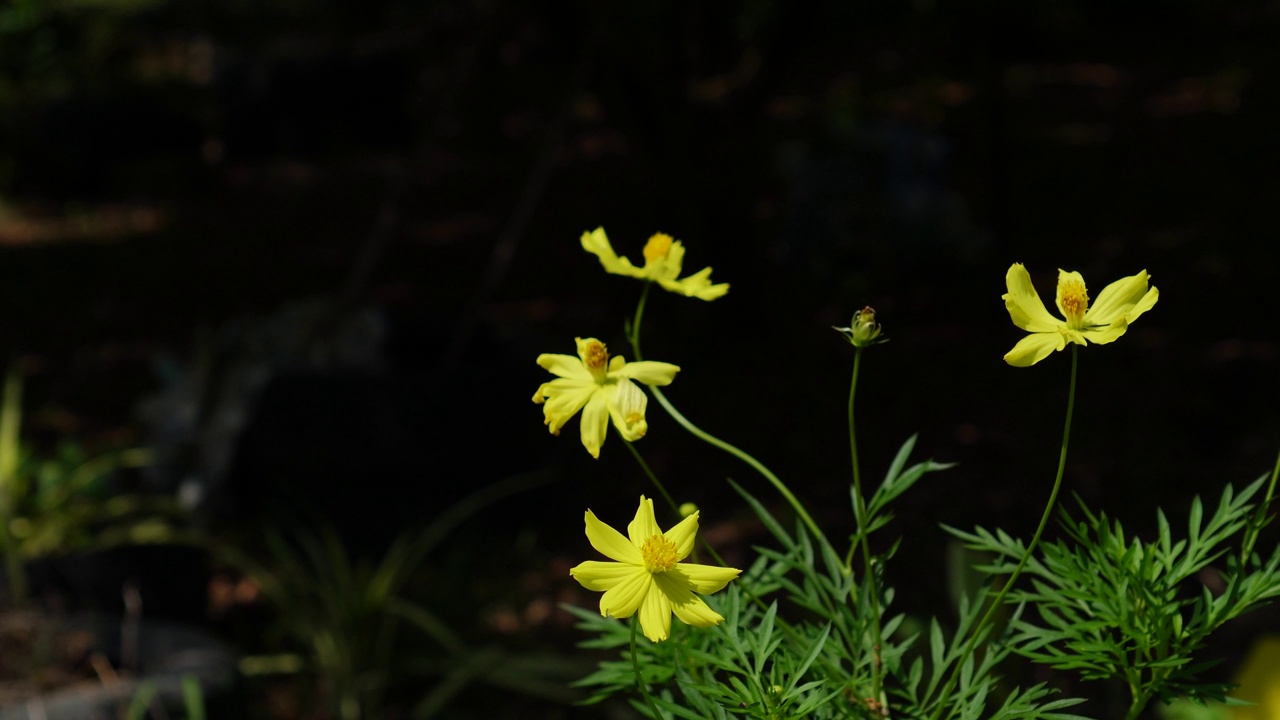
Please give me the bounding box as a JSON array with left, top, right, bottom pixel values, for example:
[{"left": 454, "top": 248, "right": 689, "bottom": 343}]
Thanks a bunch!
[{"left": 1004, "top": 263, "right": 1160, "bottom": 368}]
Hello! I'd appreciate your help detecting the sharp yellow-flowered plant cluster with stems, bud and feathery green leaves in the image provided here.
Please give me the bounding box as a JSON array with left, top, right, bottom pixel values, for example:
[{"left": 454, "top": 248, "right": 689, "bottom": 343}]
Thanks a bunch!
[{"left": 534, "top": 229, "right": 1280, "bottom": 720}]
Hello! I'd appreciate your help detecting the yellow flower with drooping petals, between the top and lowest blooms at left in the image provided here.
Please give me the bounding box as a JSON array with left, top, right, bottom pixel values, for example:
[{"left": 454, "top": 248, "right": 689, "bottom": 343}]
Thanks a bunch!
[{"left": 534, "top": 337, "right": 680, "bottom": 457}]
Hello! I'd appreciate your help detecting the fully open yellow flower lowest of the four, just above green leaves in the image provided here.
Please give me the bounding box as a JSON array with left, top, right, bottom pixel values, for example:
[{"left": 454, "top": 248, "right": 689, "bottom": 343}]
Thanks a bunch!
[{"left": 568, "top": 495, "right": 741, "bottom": 642}]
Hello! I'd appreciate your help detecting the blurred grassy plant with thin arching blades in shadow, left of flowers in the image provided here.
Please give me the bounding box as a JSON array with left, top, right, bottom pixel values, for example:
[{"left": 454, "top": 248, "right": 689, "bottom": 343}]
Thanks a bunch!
[{"left": 219, "top": 473, "right": 580, "bottom": 720}]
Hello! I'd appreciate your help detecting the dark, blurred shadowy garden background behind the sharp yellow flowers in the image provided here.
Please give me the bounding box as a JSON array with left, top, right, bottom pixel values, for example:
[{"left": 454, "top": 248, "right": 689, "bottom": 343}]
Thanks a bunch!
[{"left": 0, "top": 0, "right": 1280, "bottom": 719}]
